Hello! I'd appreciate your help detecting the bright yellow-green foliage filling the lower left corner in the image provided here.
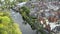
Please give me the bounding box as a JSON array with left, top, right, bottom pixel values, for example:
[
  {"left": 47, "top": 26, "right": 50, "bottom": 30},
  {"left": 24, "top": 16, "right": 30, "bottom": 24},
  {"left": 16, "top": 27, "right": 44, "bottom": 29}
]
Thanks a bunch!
[{"left": 0, "top": 12, "right": 22, "bottom": 34}]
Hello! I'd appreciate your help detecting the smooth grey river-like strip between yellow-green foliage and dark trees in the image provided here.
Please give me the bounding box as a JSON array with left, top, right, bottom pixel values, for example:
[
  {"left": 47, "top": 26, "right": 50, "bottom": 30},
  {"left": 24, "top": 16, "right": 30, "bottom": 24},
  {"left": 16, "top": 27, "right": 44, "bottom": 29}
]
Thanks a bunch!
[{"left": 10, "top": 10, "right": 36, "bottom": 34}]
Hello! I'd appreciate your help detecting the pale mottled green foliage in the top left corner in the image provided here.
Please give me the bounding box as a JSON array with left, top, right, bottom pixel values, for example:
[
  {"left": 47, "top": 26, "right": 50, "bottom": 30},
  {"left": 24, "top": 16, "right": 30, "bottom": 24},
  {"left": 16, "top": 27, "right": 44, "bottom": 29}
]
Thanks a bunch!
[{"left": 0, "top": 0, "right": 28, "bottom": 10}]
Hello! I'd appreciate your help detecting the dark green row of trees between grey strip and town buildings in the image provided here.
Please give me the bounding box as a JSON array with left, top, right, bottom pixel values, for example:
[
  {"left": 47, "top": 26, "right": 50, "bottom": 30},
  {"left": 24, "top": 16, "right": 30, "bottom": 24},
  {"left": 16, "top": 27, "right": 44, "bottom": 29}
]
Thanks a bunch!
[{"left": 19, "top": 6, "right": 46, "bottom": 34}]
